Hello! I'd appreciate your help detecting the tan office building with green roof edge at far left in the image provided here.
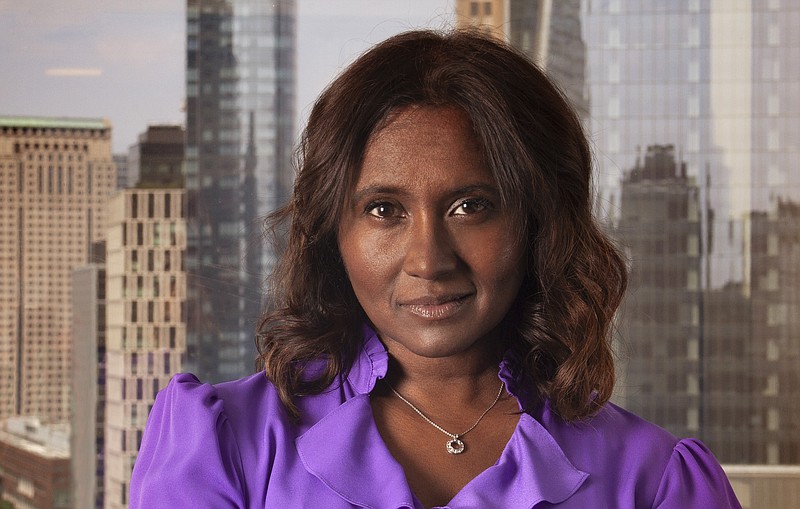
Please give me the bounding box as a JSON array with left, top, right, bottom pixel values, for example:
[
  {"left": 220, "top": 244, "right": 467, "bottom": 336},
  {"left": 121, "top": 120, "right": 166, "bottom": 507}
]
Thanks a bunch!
[{"left": 0, "top": 117, "right": 116, "bottom": 422}]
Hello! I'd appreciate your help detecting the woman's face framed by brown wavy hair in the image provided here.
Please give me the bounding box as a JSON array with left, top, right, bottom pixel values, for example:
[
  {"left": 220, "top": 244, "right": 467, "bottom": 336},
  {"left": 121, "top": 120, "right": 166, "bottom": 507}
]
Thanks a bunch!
[{"left": 339, "top": 107, "right": 525, "bottom": 357}]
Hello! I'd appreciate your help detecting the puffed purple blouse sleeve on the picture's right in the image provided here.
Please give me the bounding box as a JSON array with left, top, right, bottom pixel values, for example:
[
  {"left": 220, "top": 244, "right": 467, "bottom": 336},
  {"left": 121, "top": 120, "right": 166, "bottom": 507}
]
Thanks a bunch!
[{"left": 653, "top": 438, "right": 742, "bottom": 509}]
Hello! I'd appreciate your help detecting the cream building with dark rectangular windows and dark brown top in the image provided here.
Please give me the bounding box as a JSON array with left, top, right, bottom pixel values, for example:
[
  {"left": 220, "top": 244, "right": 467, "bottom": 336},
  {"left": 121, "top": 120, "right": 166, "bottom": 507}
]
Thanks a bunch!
[{"left": 102, "top": 126, "right": 186, "bottom": 508}]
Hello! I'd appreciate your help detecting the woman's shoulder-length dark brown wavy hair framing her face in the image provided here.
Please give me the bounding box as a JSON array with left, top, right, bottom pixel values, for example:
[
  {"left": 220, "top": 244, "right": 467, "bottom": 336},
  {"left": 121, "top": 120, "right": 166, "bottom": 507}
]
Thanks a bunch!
[{"left": 257, "top": 31, "right": 627, "bottom": 421}]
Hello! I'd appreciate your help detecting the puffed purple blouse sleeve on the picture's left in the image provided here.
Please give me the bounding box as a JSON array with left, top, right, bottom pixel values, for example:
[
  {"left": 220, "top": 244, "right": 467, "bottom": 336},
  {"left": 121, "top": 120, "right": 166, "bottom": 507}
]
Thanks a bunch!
[{"left": 130, "top": 374, "right": 246, "bottom": 509}]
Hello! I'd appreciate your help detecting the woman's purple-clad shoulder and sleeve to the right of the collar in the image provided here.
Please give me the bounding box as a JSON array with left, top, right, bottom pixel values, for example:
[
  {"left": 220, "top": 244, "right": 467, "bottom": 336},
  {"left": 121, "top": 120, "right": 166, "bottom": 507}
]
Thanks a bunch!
[{"left": 535, "top": 403, "right": 739, "bottom": 509}]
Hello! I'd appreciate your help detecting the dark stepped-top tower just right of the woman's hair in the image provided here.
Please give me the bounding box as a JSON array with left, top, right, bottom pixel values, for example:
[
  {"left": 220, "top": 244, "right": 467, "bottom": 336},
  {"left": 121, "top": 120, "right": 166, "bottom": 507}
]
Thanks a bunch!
[{"left": 617, "top": 145, "right": 703, "bottom": 436}]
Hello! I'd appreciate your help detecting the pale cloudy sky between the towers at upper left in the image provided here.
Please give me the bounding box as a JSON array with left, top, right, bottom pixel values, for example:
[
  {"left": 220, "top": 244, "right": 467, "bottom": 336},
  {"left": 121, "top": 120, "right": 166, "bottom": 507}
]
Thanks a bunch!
[{"left": 0, "top": 0, "right": 455, "bottom": 153}]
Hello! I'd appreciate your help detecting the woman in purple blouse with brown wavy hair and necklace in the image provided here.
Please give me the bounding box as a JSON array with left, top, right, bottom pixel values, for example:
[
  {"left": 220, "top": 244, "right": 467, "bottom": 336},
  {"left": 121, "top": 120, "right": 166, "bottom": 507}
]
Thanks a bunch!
[{"left": 131, "top": 32, "right": 739, "bottom": 508}]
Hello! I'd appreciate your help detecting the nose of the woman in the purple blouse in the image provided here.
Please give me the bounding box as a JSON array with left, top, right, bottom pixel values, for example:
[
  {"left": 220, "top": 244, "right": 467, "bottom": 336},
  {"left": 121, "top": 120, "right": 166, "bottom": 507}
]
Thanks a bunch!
[{"left": 403, "top": 213, "right": 458, "bottom": 280}]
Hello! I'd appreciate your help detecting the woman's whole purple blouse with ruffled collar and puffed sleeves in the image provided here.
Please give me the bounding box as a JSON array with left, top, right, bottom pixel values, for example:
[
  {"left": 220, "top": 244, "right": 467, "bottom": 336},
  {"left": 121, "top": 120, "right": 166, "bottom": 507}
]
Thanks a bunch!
[{"left": 130, "top": 330, "right": 741, "bottom": 509}]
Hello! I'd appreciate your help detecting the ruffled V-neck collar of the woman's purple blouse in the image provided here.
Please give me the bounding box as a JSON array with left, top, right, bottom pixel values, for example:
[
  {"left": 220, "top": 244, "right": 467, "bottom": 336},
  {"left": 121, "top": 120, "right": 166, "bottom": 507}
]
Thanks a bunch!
[{"left": 296, "top": 327, "right": 588, "bottom": 509}]
